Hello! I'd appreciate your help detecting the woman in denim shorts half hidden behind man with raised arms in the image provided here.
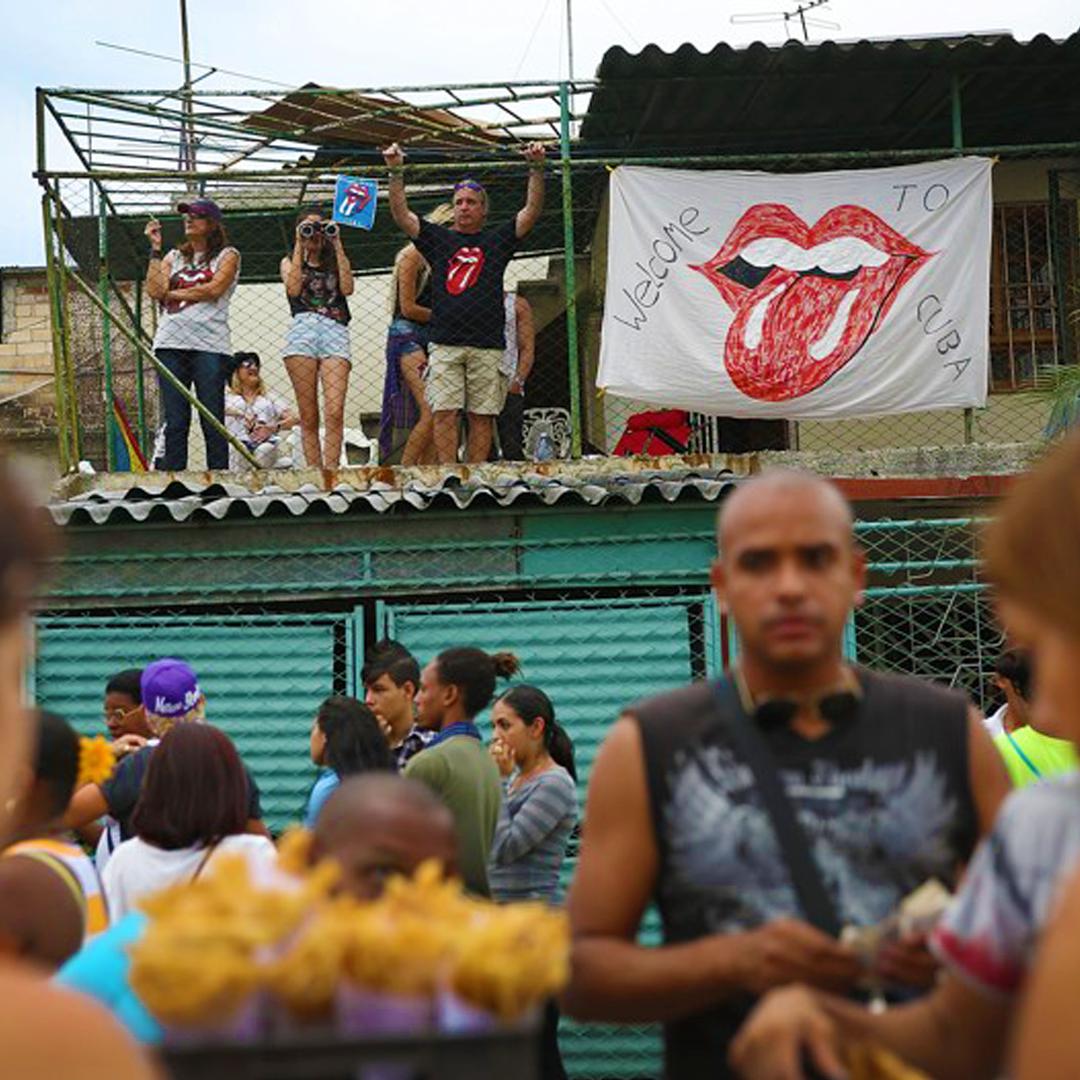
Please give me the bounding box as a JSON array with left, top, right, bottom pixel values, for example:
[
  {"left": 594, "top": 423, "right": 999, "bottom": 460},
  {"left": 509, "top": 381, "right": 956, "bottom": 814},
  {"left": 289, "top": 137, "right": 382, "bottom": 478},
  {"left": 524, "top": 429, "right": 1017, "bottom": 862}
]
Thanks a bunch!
[{"left": 379, "top": 203, "right": 454, "bottom": 465}]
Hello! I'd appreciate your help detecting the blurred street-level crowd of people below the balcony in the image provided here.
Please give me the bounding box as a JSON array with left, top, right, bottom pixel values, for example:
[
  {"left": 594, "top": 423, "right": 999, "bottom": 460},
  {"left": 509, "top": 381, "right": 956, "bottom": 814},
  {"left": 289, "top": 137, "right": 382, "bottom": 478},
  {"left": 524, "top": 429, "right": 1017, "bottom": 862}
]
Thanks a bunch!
[{"left": 0, "top": 435, "right": 1080, "bottom": 1080}]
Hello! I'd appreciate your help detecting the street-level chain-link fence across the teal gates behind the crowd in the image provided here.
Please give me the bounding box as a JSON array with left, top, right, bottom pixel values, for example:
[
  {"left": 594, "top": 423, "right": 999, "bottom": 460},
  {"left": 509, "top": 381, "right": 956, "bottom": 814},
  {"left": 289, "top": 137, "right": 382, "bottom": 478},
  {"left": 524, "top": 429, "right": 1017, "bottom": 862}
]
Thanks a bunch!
[{"left": 32, "top": 507, "right": 1001, "bottom": 1078}]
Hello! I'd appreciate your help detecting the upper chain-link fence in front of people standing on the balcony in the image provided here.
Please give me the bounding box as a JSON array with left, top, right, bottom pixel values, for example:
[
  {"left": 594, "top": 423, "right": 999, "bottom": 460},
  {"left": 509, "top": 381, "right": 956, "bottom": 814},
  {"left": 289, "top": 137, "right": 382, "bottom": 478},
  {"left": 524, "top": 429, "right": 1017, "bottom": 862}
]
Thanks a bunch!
[{"left": 47, "top": 162, "right": 569, "bottom": 469}]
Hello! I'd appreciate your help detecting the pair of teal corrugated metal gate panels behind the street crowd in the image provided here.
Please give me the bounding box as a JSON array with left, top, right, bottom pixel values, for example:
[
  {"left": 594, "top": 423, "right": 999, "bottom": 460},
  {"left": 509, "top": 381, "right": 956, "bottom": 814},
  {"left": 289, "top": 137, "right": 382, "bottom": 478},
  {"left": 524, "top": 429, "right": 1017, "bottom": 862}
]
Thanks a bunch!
[{"left": 30, "top": 592, "right": 720, "bottom": 1080}]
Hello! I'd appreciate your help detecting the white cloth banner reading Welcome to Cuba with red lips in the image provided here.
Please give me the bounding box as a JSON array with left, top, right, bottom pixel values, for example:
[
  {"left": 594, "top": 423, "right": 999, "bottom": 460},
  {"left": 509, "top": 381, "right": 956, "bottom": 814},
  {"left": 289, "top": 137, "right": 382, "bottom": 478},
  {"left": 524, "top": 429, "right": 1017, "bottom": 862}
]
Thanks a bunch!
[{"left": 597, "top": 158, "right": 993, "bottom": 419}]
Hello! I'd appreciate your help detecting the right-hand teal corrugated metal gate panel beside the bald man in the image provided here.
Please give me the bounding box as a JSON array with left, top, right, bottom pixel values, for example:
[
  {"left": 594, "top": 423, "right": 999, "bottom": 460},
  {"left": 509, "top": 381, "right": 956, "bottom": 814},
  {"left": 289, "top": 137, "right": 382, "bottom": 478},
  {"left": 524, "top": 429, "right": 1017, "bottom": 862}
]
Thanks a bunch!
[{"left": 383, "top": 596, "right": 718, "bottom": 1078}]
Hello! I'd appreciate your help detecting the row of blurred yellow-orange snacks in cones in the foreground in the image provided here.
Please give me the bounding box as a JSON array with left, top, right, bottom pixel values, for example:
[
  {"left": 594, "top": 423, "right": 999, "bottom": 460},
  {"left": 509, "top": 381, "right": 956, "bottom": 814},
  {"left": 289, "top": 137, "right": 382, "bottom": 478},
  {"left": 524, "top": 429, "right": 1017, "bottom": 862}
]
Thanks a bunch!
[{"left": 131, "top": 834, "right": 569, "bottom": 1026}]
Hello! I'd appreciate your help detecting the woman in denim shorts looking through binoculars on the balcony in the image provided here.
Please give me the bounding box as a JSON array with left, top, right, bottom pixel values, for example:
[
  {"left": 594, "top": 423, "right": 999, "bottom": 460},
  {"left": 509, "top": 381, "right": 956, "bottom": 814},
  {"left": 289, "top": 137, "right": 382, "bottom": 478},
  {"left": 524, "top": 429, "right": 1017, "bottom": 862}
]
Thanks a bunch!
[{"left": 281, "top": 210, "right": 353, "bottom": 469}]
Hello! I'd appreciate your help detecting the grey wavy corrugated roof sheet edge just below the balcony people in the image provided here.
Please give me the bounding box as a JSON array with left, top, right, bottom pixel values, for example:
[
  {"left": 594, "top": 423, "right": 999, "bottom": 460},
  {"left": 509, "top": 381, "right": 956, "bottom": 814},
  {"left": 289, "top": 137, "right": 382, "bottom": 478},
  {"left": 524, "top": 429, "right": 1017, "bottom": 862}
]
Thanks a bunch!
[{"left": 49, "top": 461, "right": 735, "bottom": 525}]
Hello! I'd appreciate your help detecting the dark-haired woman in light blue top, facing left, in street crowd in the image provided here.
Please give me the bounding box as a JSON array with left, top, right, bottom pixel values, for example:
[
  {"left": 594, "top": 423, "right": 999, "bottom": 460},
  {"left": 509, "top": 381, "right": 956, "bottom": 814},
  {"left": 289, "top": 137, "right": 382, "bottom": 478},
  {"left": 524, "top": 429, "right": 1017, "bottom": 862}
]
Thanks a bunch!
[{"left": 303, "top": 696, "right": 394, "bottom": 828}]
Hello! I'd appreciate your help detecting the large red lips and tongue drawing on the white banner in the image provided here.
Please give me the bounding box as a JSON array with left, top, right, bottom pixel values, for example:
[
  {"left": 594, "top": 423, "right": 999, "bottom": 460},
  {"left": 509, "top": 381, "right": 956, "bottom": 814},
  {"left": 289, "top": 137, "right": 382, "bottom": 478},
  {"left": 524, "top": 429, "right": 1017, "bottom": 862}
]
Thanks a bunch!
[{"left": 693, "top": 203, "right": 932, "bottom": 402}]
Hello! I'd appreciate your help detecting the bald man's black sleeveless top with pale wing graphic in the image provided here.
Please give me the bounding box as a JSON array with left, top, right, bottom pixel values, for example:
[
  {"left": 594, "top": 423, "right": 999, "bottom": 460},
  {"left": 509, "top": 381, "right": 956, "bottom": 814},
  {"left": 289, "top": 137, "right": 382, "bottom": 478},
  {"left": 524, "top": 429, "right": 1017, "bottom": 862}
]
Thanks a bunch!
[{"left": 629, "top": 670, "right": 977, "bottom": 1080}]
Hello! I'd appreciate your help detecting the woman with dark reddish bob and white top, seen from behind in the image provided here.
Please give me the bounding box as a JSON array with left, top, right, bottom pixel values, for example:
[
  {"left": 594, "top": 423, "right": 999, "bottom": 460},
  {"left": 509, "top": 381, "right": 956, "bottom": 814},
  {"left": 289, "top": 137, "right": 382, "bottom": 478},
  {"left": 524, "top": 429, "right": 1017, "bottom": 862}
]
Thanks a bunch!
[{"left": 103, "top": 723, "right": 275, "bottom": 922}]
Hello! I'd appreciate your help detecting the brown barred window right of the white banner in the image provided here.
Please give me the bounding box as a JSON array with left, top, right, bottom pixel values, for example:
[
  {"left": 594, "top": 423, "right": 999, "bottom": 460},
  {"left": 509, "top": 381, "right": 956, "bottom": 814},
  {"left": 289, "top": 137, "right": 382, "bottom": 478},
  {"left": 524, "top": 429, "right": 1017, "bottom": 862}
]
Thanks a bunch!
[{"left": 990, "top": 203, "right": 1077, "bottom": 390}]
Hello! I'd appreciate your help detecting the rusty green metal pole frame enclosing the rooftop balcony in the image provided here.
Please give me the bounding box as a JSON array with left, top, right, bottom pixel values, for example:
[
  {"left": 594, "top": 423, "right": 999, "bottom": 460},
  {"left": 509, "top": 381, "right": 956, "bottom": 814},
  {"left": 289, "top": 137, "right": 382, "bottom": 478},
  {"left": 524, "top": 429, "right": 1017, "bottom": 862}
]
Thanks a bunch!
[{"left": 35, "top": 77, "right": 1080, "bottom": 471}]
